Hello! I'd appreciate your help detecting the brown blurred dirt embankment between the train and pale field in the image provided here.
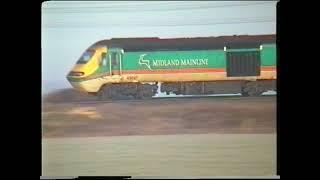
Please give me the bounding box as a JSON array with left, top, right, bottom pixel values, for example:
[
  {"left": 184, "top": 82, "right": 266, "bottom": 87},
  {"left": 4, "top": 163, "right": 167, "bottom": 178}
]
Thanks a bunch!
[{"left": 42, "top": 96, "right": 276, "bottom": 138}]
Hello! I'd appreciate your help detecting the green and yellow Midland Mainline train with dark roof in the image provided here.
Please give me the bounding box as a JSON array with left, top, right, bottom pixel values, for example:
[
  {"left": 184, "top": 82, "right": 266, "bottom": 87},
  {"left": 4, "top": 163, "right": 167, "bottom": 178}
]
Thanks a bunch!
[{"left": 66, "top": 34, "right": 277, "bottom": 100}]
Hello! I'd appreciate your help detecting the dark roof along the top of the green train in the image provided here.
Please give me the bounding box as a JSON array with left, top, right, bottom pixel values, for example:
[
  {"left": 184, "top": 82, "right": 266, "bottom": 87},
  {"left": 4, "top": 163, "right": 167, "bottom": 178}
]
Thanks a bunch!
[{"left": 91, "top": 34, "right": 276, "bottom": 51}]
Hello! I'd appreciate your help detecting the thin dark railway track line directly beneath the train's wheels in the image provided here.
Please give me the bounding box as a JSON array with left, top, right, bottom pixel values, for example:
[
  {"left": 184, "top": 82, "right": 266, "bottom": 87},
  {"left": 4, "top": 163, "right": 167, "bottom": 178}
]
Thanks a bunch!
[{"left": 52, "top": 94, "right": 277, "bottom": 104}]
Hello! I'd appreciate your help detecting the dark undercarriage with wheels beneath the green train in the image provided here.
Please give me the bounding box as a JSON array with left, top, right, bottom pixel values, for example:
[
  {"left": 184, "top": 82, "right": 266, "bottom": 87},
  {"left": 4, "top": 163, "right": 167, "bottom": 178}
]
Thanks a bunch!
[{"left": 96, "top": 80, "right": 276, "bottom": 100}]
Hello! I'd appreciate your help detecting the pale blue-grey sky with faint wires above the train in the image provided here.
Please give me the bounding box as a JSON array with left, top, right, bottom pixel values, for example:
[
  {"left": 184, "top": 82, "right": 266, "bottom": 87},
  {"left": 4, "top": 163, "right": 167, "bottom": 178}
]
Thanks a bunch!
[{"left": 41, "top": 1, "right": 276, "bottom": 93}]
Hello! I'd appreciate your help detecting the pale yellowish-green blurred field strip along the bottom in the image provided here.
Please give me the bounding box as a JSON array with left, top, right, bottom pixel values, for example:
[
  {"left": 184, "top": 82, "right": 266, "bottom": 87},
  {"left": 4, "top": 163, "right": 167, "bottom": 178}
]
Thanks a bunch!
[{"left": 42, "top": 134, "right": 276, "bottom": 177}]
